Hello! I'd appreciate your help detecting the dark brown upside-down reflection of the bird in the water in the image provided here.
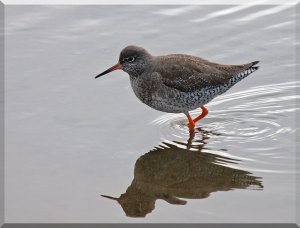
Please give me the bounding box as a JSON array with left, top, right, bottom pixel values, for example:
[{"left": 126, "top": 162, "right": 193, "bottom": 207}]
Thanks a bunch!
[{"left": 102, "top": 130, "right": 263, "bottom": 217}]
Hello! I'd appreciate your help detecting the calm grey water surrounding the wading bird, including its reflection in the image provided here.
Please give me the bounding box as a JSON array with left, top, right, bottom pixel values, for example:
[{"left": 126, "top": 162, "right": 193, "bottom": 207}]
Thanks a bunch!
[{"left": 5, "top": 5, "right": 300, "bottom": 223}]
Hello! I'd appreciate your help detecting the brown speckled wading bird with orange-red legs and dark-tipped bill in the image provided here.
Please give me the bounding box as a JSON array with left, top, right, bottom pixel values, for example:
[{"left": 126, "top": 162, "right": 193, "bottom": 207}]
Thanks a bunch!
[{"left": 95, "top": 46, "right": 259, "bottom": 130}]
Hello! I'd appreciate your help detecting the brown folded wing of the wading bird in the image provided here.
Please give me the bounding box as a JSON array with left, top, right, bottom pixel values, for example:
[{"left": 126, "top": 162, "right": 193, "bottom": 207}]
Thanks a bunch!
[{"left": 154, "top": 55, "right": 256, "bottom": 92}]
